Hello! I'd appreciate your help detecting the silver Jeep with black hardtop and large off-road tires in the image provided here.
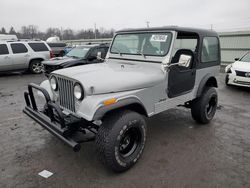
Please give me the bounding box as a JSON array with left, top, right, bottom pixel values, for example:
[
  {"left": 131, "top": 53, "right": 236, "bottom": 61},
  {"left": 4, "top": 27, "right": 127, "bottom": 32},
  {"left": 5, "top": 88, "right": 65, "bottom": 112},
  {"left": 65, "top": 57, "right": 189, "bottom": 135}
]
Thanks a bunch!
[{"left": 24, "top": 27, "right": 220, "bottom": 172}]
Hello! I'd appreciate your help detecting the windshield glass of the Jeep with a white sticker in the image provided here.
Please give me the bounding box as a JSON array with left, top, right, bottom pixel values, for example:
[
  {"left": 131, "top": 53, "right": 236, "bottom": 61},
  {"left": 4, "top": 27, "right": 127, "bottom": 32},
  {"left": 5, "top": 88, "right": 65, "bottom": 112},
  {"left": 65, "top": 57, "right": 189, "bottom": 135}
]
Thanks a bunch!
[{"left": 111, "top": 32, "right": 172, "bottom": 56}]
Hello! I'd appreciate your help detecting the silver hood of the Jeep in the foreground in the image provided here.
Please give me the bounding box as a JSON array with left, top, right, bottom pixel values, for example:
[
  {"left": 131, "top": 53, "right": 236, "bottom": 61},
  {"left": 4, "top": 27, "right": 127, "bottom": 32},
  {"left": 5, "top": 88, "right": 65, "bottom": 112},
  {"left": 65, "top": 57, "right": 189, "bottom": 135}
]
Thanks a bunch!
[{"left": 54, "top": 63, "right": 164, "bottom": 94}]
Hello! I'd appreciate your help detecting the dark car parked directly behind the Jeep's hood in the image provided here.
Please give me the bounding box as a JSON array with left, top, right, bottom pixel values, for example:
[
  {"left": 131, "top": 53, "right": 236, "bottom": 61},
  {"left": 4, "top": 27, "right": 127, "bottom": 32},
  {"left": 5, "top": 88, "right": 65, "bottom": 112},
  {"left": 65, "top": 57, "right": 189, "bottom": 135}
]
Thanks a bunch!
[{"left": 42, "top": 44, "right": 109, "bottom": 77}]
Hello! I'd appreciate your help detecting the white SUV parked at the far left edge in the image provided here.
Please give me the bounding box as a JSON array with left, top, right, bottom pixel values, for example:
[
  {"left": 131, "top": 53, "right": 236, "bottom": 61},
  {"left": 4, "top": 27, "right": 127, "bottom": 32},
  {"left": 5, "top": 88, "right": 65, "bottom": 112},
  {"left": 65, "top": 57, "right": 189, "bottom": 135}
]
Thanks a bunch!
[{"left": 0, "top": 41, "right": 53, "bottom": 74}]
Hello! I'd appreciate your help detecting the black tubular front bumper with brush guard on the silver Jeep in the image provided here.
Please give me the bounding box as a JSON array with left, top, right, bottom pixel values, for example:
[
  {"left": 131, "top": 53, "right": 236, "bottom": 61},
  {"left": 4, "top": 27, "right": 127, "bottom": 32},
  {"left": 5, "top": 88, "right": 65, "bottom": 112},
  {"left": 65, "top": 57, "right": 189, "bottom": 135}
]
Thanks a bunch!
[{"left": 23, "top": 83, "right": 97, "bottom": 151}]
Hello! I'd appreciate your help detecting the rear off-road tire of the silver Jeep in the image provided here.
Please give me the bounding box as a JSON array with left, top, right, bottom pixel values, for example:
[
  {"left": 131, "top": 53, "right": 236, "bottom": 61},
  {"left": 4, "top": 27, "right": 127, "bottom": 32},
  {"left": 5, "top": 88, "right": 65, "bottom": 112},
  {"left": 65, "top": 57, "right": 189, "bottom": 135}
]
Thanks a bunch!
[{"left": 191, "top": 87, "right": 218, "bottom": 124}]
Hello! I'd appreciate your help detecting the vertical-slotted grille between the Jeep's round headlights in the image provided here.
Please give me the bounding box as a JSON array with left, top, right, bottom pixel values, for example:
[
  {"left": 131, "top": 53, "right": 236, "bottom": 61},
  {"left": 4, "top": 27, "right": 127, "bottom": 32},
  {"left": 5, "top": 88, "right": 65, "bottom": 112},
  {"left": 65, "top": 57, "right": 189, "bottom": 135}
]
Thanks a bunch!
[{"left": 57, "top": 77, "right": 75, "bottom": 112}]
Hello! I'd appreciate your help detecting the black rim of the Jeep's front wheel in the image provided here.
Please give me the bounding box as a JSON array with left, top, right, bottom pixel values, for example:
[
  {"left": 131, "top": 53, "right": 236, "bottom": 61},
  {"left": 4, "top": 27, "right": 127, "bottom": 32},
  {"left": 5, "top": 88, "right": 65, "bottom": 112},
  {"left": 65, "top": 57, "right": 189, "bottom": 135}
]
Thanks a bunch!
[{"left": 119, "top": 127, "right": 142, "bottom": 158}]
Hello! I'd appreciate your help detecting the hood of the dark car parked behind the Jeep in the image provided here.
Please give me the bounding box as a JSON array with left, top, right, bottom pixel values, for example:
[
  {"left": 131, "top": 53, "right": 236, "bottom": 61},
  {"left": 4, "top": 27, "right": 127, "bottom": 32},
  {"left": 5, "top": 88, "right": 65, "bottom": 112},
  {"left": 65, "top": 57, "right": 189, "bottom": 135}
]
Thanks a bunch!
[{"left": 42, "top": 56, "right": 84, "bottom": 67}]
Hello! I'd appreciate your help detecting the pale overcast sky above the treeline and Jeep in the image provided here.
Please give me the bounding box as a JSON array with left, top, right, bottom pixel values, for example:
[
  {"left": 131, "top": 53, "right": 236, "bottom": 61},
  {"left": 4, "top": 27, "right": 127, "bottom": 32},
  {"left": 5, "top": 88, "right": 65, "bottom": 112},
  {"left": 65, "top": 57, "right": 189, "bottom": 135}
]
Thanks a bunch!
[{"left": 0, "top": 0, "right": 250, "bottom": 31}]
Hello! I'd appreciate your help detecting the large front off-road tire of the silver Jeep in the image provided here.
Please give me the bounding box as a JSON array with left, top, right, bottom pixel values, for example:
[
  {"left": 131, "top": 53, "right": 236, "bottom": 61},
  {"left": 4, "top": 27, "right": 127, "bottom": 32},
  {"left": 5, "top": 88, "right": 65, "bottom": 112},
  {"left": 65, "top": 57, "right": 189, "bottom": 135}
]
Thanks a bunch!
[{"left": 96, "top": 110, "right": 147, "bottom": 172}]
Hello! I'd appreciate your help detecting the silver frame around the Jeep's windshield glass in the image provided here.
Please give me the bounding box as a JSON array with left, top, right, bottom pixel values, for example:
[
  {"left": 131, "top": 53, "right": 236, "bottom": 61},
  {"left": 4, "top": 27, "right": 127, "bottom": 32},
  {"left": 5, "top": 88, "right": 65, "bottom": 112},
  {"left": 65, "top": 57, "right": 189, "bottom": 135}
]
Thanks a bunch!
[{"left": 110, "top": 30, "right": 173, "bottom": 58}]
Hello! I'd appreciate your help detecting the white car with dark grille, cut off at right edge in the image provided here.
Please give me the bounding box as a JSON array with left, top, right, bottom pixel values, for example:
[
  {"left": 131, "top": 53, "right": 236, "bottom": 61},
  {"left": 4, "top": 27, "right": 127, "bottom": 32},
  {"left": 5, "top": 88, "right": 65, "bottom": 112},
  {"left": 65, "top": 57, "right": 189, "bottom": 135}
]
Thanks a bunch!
[{"left": 225, "top": 52, "right": 250, "bottom": 87}]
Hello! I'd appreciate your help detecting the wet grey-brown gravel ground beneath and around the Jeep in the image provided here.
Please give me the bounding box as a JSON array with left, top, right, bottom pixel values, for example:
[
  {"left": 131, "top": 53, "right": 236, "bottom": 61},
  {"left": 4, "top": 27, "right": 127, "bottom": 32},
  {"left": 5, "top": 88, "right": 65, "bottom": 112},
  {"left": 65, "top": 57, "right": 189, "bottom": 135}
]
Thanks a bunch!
[{"left": 0, "top": 74, "right": 250, "bottom": 188}]
